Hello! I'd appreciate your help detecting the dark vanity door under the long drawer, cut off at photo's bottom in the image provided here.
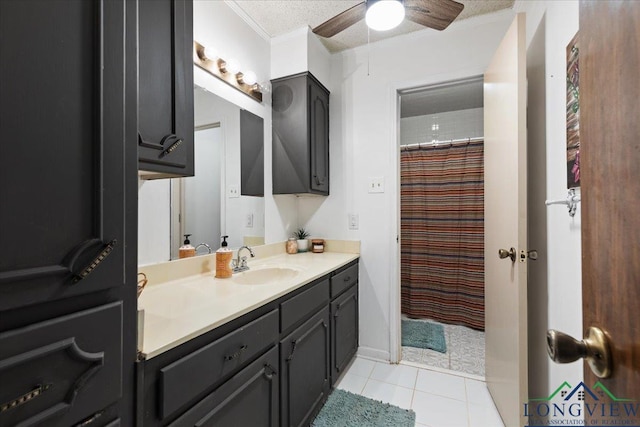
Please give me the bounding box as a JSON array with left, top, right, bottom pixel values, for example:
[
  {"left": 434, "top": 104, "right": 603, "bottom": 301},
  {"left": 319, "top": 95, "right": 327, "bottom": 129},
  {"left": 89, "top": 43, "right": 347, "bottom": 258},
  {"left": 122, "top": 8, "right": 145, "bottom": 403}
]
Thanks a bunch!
[{"left": 170, "top": 347, "right": 280, "bottom": 427}]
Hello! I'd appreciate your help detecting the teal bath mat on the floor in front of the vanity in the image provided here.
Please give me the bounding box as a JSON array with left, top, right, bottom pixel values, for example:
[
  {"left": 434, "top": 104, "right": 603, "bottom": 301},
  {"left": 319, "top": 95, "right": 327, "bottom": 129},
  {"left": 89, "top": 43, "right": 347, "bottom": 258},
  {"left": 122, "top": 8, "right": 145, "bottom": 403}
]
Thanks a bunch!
[{"left": 311, "top": 389, "right": 416, "bottom": 427}]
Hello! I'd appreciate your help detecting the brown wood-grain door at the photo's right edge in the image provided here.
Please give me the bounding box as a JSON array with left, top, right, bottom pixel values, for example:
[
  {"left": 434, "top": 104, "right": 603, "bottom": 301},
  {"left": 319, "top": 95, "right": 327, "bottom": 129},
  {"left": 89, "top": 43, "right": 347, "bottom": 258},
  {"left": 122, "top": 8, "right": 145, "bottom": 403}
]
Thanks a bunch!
[{"left": 579, "top": 1, "right": 640, "bottom": 425}]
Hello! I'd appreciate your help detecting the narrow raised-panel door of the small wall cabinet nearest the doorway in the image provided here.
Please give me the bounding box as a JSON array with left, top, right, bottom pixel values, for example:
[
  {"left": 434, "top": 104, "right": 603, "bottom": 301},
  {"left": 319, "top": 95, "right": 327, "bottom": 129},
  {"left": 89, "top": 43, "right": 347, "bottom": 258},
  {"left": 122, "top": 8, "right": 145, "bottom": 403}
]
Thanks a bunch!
[{"left": 309, "top": 79, "right": 329, "bottom": 195}]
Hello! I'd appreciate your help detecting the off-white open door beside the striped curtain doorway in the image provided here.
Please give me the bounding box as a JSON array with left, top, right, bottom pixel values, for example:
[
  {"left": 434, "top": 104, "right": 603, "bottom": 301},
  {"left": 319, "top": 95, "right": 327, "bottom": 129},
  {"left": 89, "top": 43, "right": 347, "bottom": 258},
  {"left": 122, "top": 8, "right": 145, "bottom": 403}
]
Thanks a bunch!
[{"left": 484, "top": 14, "right": 527, "bottom": 426}]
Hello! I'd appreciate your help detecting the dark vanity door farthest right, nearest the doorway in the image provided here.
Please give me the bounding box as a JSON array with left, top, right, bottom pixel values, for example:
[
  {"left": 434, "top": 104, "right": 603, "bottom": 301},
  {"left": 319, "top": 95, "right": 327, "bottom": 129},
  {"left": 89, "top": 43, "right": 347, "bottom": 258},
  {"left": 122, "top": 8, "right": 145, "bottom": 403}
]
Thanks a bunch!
[{"left": 331, "top": 285, "right": 358, "bottom": 385}]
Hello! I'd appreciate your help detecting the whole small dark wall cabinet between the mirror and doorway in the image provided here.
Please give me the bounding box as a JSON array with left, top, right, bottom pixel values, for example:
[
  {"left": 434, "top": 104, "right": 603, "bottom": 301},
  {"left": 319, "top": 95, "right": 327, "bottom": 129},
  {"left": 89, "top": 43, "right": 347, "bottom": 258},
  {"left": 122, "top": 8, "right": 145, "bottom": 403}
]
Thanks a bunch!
[{"left": 271, "top": 72, "right": 329, "bottom": 196}]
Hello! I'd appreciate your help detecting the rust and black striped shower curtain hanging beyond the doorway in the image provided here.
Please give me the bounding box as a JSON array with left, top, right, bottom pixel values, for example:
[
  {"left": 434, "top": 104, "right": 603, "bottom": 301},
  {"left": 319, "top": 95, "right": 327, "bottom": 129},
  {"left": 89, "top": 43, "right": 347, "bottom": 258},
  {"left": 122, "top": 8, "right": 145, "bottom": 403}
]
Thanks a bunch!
[{"left": 400, "top": 141, "right": 484, "bottom": 330}]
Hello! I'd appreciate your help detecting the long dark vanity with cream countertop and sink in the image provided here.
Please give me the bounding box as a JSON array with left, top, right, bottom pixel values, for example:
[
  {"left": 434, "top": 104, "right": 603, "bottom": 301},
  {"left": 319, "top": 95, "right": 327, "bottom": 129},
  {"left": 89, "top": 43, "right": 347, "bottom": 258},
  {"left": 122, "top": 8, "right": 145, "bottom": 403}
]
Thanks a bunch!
[{"left": 136, "top": 241, "right": 359, "bottom": 426}]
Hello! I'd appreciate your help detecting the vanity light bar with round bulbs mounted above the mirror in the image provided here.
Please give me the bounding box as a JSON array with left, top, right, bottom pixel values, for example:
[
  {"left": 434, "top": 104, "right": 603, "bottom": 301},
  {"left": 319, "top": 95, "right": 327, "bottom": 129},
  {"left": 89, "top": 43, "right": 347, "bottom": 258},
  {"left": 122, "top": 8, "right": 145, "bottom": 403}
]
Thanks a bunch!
[{"left": 193, "top": 41, "right": 263, "bottom": 103}]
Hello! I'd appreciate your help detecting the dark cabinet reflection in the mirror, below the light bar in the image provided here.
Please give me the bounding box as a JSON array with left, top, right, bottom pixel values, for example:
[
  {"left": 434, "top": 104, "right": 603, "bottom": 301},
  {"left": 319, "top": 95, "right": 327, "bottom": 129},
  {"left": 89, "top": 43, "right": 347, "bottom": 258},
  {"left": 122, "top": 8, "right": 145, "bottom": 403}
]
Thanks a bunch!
[{"left": 240, "top": 110, "right": 264, "bottom": 197}]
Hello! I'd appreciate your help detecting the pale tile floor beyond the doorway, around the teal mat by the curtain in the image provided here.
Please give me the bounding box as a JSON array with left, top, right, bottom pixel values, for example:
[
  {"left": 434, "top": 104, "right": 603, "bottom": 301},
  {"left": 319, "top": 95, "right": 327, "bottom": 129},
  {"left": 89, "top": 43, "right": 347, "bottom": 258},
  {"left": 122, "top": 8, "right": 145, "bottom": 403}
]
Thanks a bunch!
[{"left": 402, "top": 319, "right": 484, "bottom": 377}]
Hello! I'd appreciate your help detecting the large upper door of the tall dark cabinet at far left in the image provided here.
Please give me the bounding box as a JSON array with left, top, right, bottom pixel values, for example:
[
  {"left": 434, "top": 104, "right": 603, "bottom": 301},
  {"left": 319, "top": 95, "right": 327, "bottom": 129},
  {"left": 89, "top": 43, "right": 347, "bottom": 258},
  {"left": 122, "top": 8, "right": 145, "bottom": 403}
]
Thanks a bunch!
[{"left": 0, "top": 0, "right": 129, "bottom": 311}]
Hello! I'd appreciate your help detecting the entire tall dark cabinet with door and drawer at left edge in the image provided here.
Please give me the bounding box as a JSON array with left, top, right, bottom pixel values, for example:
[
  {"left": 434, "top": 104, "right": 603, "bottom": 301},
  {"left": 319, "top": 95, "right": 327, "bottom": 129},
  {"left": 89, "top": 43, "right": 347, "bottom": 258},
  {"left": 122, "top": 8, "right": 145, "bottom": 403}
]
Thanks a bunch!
[{"left": 0, "top": 0, "right": 137, "bottom": 427}]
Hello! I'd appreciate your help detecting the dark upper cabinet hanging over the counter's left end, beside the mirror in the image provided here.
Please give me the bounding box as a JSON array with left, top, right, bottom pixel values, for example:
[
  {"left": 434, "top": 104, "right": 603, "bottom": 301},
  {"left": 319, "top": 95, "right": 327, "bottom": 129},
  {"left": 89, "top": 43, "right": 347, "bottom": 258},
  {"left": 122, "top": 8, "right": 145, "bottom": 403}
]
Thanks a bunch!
[{"left": 138, "top": 0, "right": 194, "bottom": 178}]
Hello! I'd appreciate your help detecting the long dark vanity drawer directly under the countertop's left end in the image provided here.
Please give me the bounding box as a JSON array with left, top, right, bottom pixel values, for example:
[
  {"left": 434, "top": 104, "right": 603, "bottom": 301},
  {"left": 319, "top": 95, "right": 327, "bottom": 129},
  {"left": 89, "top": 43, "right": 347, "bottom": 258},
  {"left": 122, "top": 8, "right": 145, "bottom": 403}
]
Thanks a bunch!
[{"left": 159, "top": 309, "right": 279, "bottom": 419}]
